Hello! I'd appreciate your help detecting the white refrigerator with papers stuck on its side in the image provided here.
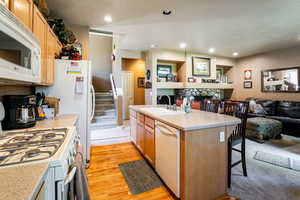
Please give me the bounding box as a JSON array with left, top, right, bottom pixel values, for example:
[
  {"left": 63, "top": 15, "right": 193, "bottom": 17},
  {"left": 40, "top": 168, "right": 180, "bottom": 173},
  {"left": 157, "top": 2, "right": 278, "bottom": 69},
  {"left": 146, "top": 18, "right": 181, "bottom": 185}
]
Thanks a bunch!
[{"left": 37, "top": 60, "right": 95, "bottom": 162}]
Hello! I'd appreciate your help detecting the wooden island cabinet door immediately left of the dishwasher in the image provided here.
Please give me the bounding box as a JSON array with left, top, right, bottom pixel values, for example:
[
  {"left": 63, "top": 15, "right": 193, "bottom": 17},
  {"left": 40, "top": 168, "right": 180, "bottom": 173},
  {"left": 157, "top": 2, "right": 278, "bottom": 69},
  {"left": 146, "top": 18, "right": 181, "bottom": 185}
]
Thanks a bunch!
[{"left": 144, "top": 126, "right": 155, "bottom": 166}]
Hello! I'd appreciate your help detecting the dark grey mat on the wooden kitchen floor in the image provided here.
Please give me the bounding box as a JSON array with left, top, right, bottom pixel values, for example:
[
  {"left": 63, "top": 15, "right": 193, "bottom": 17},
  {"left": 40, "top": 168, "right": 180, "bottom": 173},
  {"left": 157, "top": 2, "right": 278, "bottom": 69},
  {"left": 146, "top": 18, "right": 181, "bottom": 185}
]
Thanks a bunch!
[{"left": 119, "top": 160, "right": 163, "bottom": 195}]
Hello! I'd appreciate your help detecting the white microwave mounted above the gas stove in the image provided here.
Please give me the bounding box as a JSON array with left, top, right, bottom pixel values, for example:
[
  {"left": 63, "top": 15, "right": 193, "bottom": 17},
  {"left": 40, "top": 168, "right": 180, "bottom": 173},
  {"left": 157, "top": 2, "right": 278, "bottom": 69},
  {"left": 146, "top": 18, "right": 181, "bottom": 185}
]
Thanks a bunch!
[{"left": 0, "top": 3, "right": 41, "bottom": 83}]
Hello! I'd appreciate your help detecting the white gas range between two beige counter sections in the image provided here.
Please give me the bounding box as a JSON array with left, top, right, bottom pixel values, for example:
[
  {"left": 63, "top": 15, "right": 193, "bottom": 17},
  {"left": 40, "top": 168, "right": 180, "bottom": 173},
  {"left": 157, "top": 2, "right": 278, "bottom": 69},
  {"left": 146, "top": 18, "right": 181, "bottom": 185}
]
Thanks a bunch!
[{"left": 0, "top": 127, "right": 77, "bottom": 200}]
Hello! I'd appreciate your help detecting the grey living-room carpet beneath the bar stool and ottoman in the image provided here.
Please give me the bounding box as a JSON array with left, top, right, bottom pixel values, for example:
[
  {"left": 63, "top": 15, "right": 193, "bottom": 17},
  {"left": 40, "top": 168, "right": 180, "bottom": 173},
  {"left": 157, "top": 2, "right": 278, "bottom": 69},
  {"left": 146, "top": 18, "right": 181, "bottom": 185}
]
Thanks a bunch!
[{"left": 229, "top": 138, "right": 300, "bottom": 200}]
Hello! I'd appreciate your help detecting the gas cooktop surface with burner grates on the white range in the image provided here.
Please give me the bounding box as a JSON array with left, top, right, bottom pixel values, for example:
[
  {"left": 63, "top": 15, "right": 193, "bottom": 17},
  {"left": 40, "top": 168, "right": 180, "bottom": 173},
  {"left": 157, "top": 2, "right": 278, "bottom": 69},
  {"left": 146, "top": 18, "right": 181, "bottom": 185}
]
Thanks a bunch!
[{"left": 0, "top": 129, "right": 67, "bottom": 167}]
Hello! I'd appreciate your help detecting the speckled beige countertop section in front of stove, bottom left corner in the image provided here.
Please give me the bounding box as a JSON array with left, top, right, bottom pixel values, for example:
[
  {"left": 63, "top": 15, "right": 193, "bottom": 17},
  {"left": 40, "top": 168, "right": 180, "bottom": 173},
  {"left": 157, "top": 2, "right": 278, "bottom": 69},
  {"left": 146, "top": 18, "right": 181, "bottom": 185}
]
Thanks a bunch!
[{"left": 0, "top": 162, "right": 48, "bottom": 200}]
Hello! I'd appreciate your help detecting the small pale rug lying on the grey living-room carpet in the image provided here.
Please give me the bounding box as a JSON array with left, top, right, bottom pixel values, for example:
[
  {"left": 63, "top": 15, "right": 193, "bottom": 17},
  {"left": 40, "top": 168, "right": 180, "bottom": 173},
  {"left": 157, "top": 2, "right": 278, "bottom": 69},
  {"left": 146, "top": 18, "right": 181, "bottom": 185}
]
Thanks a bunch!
[{"left": 254, "top": 151, "right": 300, "bottom": 171}]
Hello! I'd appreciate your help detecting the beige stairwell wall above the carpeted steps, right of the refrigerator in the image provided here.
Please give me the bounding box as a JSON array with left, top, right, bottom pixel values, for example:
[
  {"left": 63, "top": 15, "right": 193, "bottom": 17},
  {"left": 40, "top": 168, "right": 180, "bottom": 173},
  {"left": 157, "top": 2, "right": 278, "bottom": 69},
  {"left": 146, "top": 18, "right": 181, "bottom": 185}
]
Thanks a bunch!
[{"left": 89, "top": 34, "right": 112, "bottom": 91}]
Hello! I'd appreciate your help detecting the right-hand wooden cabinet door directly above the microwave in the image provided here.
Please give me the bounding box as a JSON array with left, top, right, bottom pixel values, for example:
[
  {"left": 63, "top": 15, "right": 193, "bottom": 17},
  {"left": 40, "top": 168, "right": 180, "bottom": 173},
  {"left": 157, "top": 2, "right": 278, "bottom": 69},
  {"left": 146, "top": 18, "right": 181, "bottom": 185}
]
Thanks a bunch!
[{"left": 9, "top": 0, "right": 33, "bottom": 30}]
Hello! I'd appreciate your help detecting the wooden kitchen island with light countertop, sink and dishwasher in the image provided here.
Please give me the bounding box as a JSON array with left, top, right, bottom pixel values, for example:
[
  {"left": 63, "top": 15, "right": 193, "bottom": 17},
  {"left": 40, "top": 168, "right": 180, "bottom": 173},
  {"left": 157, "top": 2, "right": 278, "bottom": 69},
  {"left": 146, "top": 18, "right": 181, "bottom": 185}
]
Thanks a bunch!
[{"left": 130, "top": 106, "right": 241, "bottom": 200}]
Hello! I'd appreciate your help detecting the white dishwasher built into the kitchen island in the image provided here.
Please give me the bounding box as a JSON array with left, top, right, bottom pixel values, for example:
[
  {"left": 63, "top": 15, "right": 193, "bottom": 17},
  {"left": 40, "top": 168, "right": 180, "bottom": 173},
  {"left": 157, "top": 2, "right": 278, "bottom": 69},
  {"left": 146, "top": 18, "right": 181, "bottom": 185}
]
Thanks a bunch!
[{"left": 155, "top": 121, "right": 180, "bottom": 198}]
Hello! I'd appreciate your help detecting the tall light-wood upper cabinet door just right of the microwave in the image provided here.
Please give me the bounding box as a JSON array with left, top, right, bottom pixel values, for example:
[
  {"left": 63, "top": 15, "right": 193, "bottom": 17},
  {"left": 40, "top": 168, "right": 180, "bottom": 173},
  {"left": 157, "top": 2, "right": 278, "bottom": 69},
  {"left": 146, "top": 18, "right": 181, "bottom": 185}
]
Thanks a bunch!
[{"left": 32, "top": 6, "right": 48, "bottom": 84}]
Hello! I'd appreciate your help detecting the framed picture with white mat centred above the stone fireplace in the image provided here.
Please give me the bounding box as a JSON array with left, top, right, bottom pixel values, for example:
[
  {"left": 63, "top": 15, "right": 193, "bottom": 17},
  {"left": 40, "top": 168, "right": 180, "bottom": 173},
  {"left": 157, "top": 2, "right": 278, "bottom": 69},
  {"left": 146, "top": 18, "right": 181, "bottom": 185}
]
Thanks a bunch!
[{"left": 192, "top": 56, "right": 211, "bottom": 76}]
